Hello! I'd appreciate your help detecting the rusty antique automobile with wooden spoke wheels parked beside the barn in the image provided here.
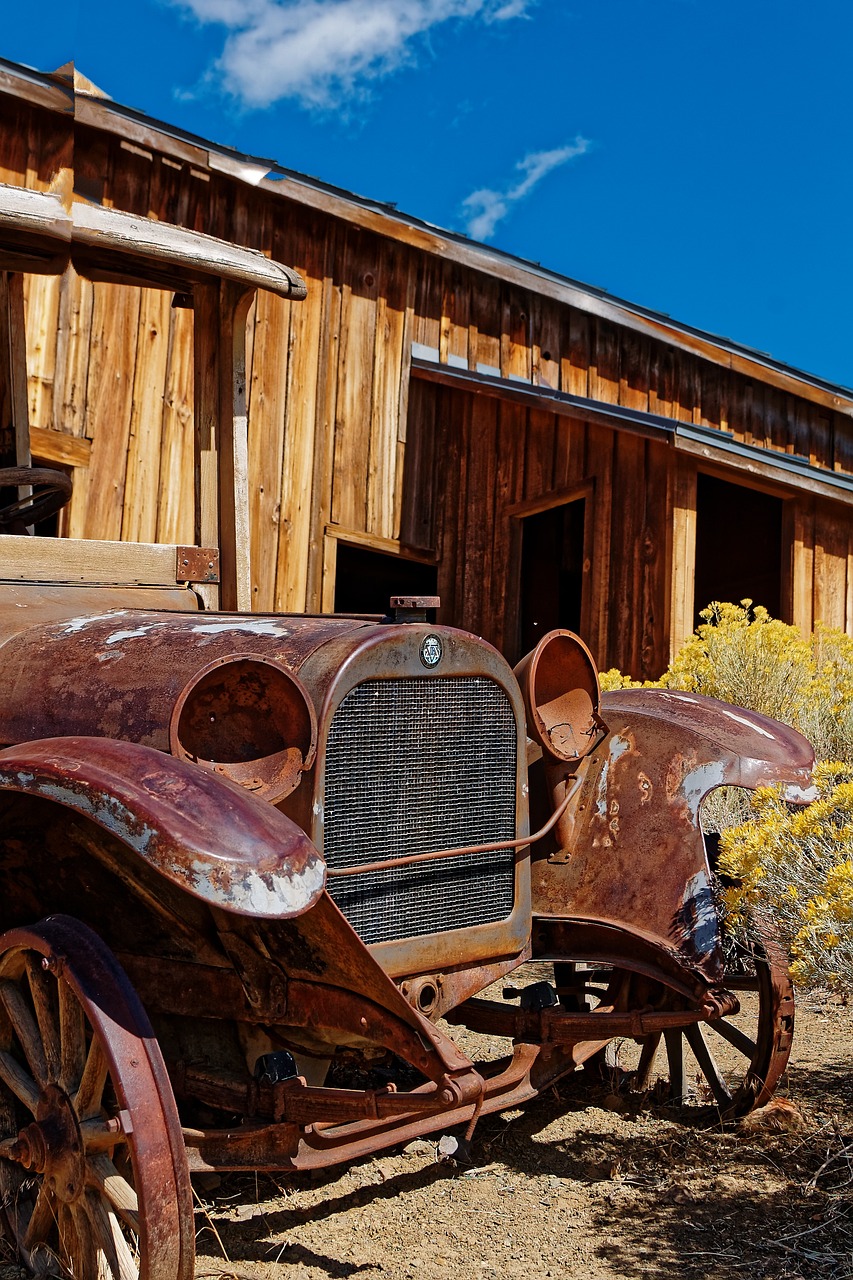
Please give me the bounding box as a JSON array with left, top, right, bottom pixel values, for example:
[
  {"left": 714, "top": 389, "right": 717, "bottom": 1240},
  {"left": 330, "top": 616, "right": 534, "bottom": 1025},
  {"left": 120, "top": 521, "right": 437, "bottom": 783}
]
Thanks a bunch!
[{"left": 0, "top": 188, "right": 812, "bottom": 1280}]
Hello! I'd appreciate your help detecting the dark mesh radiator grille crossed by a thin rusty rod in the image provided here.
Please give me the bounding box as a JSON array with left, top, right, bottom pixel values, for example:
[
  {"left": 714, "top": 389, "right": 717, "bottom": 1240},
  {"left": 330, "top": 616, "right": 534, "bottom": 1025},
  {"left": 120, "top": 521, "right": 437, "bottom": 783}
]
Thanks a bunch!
[{"left": 324, "top": 676, "right": 517, "bottom": 943}]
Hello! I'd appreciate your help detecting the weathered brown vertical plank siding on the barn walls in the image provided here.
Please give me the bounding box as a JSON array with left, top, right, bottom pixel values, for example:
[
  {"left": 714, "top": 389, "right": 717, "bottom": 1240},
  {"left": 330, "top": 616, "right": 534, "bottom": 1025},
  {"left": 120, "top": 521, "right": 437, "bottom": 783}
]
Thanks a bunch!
[{"left": 0, "top": 77, "right": 853, "bottom": 675}]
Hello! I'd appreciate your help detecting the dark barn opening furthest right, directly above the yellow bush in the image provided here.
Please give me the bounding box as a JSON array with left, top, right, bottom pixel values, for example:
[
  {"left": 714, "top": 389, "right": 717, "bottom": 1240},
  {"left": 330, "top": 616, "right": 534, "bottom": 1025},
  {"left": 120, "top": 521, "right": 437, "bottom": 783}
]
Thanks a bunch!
[{"left": 693, "top": 475, "right": 788, "bottom": 626}]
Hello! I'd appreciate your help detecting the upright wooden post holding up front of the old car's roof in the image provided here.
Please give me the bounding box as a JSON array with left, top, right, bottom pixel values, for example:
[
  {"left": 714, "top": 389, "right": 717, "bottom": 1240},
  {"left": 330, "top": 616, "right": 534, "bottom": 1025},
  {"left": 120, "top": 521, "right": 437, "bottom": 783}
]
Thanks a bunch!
[{"left": 193, "top": 280, "right": 255, "bottom": 612}]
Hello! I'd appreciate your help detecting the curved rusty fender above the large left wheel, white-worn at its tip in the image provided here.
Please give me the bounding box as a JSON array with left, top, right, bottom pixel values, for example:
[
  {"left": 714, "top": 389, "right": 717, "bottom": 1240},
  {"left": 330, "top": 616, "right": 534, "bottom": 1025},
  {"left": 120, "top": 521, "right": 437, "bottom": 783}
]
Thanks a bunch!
[{"left": 0, "top": 737, "right": 325, "bottom": 920}]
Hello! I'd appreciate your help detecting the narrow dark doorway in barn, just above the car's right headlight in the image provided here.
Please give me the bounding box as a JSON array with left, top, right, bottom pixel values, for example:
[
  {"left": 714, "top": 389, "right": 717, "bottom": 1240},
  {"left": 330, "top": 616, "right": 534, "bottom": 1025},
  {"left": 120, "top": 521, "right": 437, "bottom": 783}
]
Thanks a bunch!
[{"left": 520, "top": 498, "right": 587, "bottom": 654}]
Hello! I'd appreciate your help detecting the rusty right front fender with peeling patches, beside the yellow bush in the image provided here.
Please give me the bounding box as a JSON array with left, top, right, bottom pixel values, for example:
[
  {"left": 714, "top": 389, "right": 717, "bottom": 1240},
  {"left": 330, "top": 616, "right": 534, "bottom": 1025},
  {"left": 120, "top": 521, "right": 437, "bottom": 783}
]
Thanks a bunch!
[{"left": 533, "top": 690, "right": 816, "bottom": 980}]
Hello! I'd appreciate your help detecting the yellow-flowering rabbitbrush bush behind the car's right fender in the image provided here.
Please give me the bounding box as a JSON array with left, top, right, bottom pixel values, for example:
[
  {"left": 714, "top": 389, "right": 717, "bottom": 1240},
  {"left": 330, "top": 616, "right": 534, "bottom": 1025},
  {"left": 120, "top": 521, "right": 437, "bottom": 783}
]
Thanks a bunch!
[{"left": 602, "top": 600, "right": 853, "bottom": 995}]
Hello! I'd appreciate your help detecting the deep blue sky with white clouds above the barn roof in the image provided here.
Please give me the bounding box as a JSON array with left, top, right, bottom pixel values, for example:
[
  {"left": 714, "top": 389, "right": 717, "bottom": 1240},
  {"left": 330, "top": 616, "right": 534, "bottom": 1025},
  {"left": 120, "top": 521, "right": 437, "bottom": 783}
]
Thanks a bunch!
[{"left": 0, "top": 0, "right": 853, "bottom": 387}]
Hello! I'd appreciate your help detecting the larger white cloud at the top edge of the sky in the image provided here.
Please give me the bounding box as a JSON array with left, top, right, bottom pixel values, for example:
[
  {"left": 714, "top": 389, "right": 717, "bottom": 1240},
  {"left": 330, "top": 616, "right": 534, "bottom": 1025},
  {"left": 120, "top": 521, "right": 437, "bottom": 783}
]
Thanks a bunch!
[{"left": 170, "top": 0, "right": 538, "bottom": 108}]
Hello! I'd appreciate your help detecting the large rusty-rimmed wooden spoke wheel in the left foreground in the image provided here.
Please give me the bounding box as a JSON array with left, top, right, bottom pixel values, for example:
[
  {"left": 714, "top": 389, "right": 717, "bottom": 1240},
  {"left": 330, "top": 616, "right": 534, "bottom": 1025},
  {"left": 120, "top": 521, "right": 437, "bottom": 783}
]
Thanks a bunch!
[{"left": 0, "top": 915, "right": 195, "bottom": 1280}]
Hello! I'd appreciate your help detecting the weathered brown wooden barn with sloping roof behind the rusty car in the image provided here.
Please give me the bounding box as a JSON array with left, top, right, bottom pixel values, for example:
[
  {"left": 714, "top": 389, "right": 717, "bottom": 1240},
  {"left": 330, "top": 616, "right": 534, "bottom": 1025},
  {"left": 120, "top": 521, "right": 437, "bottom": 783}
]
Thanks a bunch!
[{"left": 0, "top": 63, "right": 853, "bottom": 677}]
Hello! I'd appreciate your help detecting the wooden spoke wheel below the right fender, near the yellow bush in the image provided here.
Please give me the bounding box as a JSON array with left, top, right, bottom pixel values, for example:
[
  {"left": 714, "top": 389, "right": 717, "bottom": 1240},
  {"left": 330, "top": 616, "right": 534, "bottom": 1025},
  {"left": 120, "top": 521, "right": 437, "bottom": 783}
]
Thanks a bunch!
[{"left": 556, "top": 924, "right": 794, "bottom": 1119}]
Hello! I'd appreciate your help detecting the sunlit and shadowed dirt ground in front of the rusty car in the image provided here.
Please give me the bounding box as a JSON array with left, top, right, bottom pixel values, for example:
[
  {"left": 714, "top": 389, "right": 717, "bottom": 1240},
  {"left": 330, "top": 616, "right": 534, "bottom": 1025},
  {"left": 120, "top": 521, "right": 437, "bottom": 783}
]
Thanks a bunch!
[{"left": 196, "top": 996, "right": 853, "bottom": 1280}]
